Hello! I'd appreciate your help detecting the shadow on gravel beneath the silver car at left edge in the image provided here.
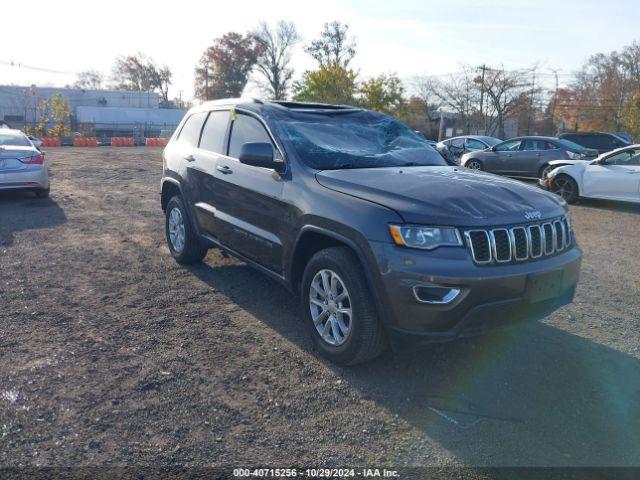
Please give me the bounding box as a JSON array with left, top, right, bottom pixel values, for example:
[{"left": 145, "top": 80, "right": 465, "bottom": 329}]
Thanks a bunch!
[{"left": 0, "top": 191, "right": 67, "bottom": 245}]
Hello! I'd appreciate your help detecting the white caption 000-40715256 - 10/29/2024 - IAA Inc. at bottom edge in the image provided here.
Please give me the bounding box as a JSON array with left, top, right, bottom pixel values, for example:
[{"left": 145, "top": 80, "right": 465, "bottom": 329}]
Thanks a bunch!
[{"left": 233, "top": 468, "right": 400, "bottom": 478}]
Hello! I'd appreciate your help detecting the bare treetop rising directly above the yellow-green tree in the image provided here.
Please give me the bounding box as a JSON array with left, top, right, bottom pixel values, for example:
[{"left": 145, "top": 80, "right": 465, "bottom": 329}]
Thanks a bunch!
[{"left": 305, "top": 20, "right": 356, "bottom": 69}]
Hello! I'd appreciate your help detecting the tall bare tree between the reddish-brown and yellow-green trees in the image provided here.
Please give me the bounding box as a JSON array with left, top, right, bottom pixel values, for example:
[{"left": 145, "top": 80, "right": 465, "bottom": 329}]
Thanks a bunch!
[{"left": 253, "top": 20, "right": 300, "bottom": 99}]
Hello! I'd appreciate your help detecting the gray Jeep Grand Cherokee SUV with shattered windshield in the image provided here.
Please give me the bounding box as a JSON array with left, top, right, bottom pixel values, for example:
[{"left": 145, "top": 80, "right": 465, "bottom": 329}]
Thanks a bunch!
[{"left": 162, "top": 100, "right": 581, "bottom": 364}]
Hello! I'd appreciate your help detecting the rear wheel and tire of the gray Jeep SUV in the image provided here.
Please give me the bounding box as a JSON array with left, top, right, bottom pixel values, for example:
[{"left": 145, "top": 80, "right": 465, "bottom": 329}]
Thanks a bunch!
[{"left": 165, "top": 195, "right": 207, "bottom": 264}]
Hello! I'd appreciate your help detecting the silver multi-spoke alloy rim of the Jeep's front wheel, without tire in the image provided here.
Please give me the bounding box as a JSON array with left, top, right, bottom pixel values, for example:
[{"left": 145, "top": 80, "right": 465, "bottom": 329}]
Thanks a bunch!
[{"left": 309, "top": 269, "right": 353, "bottom": 347}]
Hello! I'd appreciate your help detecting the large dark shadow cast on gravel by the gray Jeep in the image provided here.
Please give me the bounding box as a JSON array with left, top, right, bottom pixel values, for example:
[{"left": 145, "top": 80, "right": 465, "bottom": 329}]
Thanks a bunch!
[{"left": 191, "top": 264, "right": 640, "bottom": 466}]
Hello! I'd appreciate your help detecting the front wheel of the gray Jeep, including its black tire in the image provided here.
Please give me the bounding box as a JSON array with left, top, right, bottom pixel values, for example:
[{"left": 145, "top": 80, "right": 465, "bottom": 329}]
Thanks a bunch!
[{"left": 301, "top": 247, "right": 387, "bottom": 365}]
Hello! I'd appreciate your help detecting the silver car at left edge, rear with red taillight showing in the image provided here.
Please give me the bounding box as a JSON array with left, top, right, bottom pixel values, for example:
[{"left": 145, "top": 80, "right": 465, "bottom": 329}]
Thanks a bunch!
[{"left": 0, "top": 128, "right": 50, "bottom": 198}]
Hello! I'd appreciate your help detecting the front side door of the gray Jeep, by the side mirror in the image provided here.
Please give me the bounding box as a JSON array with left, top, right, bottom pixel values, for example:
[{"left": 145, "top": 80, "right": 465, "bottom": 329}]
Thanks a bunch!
[{"left": 214, "top": 112, "right": 289, "bottom": 274}]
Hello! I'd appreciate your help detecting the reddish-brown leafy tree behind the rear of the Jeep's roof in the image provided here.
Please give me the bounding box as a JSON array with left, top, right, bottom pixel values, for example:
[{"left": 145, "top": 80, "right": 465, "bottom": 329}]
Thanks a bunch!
[{"left": 195, "top": 32, "right": 263, "bottom": 100}]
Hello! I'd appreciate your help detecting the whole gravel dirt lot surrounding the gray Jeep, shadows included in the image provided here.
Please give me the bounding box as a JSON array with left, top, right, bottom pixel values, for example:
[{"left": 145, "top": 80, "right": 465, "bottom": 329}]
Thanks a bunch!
[{"left": 0, "top": 148, "right": 640, "bottom": 467}]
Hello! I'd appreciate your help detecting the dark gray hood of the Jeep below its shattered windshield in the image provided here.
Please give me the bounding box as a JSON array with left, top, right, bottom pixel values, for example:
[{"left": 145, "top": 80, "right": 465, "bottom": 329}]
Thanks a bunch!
[{"left": 316, "top": 166, "right": 565, "bottom": 226}]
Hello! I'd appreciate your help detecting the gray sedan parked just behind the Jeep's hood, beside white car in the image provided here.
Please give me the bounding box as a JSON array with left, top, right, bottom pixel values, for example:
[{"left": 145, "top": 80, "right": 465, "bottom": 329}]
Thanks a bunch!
[{"left": 461, "top": 137, "right": 597, "bottom": 178}]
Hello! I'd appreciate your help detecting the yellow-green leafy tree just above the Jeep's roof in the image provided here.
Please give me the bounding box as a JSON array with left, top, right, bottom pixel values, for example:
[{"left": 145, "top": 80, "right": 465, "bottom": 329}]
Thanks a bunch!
[{"left": 293, "top": 65, "right": 357, "bottom": 104}]
